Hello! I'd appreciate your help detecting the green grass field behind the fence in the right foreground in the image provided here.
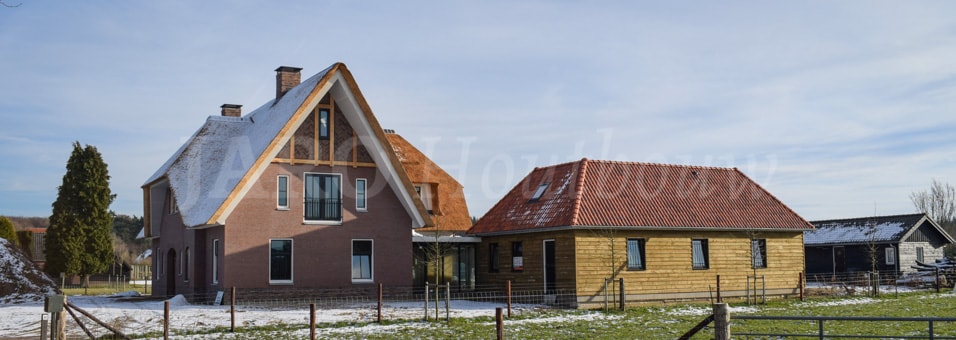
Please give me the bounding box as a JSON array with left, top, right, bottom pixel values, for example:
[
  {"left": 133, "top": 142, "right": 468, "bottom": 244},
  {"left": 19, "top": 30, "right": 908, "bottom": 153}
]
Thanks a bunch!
[{"left": 133, "top": 293, "right": 956, "bottom": 339}]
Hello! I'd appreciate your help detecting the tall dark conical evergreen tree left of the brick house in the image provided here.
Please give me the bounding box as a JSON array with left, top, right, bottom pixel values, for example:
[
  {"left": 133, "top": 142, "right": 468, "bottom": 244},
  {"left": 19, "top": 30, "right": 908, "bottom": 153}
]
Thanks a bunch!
[{"left": 45, "top": 142, "right": 116, "bottom": 287}]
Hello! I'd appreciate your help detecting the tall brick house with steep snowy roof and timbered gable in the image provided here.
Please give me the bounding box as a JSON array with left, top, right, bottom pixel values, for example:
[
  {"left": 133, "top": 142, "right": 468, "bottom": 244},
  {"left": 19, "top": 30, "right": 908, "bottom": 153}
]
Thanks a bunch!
[{"left": 143, "top": 63, "right": 432, "bottom": 296}]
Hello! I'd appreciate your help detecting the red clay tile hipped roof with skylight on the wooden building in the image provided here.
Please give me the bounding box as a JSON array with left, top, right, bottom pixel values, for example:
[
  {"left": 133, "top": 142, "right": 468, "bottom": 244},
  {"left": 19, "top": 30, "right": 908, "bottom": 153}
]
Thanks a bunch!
[{"left": 469, "top": 159, "right": 813, "bottom": 235}]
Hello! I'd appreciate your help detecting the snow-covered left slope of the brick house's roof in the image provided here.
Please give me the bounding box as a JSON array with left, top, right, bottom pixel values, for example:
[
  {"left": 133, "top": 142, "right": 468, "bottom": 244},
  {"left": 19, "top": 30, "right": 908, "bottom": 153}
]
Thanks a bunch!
[{"left": 145, "top": 65, "right": 334, "bottom": 226}]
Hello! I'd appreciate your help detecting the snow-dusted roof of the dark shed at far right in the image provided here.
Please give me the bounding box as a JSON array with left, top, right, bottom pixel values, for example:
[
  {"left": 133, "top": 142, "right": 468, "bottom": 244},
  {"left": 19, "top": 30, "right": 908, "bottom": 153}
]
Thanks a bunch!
[{"left": 803, "top": 213, "right": 953, "bottom": 246}]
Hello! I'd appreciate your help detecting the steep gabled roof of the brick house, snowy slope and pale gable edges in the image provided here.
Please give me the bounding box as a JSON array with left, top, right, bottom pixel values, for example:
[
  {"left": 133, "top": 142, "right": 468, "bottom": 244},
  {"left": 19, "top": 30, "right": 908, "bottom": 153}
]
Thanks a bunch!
[{"left": 143, "top": 63, "right": 431, "bottom": 232}]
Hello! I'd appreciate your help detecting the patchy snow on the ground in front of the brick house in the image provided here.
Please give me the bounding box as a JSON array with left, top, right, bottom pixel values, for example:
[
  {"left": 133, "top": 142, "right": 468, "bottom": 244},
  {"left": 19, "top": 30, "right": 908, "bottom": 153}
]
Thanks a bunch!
[{"left": 0, "top": 292, "right": 544, "bottom": 338}]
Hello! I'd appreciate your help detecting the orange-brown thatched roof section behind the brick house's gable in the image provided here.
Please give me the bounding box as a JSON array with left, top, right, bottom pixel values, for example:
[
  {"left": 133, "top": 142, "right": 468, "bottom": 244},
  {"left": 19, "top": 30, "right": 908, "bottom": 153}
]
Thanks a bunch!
[{"left": 385, "top": 132, "right": 471, "bottom": 232}]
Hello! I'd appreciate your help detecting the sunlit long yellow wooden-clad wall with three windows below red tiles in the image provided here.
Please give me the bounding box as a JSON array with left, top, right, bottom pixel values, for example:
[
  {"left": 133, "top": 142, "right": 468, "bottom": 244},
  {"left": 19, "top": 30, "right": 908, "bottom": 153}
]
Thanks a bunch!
[{"left": 575, "top": 230, "right": 804, "bottom": 296}]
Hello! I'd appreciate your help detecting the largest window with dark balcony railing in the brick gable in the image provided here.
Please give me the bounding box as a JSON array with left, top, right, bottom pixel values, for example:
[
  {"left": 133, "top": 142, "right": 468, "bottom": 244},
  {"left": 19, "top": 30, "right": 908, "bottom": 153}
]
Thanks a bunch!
[{"left": 305, "top": 173, "right": 342, "bottom": 221}]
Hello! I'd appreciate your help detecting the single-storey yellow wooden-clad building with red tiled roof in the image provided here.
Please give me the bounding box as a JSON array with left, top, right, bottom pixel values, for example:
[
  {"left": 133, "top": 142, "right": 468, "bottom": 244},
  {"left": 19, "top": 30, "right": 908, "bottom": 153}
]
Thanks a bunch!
[{"left": 469, "top": 159, "right": 813, "bottom": 307}]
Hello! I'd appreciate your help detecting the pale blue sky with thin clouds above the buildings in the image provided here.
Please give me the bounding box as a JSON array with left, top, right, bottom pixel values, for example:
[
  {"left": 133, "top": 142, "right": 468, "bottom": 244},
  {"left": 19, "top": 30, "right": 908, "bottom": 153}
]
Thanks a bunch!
[{"left": 0, "top": 0, "right": 956, "bottom": 220}]
